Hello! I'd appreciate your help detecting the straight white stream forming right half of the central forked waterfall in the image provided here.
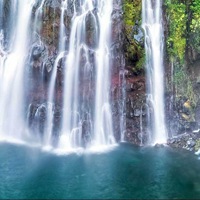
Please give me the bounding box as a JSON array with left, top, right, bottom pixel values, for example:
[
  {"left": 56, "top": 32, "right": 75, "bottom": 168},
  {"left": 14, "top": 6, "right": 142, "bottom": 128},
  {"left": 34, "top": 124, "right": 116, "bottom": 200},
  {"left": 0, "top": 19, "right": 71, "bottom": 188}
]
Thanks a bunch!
[{"left": 94, "top": 1, "right": 115, "bottom": 145}]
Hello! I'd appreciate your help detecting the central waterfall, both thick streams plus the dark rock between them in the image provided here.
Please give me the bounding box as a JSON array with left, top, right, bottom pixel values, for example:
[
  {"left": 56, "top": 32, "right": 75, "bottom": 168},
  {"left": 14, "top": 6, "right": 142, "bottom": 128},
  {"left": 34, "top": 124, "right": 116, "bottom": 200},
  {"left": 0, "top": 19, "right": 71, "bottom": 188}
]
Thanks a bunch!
[{"left": 59, "top": 0, "right": 114, "bottom": 148}]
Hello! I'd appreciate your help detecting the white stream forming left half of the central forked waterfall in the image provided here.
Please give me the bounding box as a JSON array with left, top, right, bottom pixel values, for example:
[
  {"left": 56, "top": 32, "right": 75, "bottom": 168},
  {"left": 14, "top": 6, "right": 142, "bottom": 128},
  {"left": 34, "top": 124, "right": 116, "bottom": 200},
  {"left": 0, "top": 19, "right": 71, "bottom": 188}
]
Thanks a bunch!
[{"left": 59, "top": 1, "right": 93, "bottom": 148}]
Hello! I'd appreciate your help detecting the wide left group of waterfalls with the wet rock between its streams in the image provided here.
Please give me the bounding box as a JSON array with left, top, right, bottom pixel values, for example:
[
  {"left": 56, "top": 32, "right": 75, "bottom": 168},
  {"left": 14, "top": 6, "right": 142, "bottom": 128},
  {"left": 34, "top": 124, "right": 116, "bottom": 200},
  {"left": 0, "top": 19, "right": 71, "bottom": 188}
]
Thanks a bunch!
[{"left": 0, "top": 0, "right": 115, "bottom": 149}]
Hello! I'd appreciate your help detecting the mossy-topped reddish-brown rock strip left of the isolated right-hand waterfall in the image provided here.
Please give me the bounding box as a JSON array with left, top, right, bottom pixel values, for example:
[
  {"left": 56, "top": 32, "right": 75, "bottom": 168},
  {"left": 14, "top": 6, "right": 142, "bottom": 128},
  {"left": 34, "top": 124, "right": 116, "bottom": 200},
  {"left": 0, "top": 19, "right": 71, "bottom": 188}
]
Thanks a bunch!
[{"left": 123, "top": 0, "right": 150, "bottom": 145}]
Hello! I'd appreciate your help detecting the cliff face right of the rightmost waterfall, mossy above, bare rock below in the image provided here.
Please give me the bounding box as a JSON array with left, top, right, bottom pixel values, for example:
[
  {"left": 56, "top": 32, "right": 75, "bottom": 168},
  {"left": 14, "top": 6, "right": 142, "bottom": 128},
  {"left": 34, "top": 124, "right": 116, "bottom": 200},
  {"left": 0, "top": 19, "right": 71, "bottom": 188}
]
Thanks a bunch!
[{"left": 163, "top": 0, "right": 200, "bottom": 150}]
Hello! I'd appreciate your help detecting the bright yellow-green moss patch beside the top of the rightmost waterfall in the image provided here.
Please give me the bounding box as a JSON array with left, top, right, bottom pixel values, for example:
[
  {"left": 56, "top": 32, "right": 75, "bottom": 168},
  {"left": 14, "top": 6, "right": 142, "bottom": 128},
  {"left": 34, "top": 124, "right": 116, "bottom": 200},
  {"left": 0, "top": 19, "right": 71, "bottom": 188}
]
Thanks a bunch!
[{"left": 166, "top": 0, "right": 187, "bottom": 63}]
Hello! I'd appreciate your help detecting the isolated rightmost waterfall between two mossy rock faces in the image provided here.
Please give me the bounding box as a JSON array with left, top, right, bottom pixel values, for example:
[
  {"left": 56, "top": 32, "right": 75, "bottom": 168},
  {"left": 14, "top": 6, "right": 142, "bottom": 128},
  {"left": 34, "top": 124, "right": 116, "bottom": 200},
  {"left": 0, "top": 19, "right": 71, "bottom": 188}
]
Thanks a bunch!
[{"left": 142, "top": 0, "right": 167, "bottom": 144}]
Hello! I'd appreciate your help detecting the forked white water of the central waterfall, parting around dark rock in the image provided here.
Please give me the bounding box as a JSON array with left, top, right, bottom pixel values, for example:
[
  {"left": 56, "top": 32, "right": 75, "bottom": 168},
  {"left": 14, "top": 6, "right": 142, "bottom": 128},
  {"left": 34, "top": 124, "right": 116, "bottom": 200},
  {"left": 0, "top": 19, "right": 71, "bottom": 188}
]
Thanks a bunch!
[{"left": 60, "top": 0, "right": 114, "bottom": 148}]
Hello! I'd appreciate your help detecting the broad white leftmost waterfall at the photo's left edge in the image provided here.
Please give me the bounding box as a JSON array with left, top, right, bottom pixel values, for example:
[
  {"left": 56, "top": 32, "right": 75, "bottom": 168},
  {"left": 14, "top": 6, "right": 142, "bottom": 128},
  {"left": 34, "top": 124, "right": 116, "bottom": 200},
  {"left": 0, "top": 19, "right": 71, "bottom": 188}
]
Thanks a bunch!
[{"left": 0, "top": 0, "right": 34, "bottom": 141}]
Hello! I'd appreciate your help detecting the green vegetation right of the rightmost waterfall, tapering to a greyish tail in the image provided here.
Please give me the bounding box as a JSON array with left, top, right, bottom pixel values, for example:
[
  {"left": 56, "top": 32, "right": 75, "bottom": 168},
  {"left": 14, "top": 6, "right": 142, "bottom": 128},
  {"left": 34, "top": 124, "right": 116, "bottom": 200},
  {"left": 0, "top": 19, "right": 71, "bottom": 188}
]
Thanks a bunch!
[{"left": 165, "top": 0, "right": 200, "bottom": 105}]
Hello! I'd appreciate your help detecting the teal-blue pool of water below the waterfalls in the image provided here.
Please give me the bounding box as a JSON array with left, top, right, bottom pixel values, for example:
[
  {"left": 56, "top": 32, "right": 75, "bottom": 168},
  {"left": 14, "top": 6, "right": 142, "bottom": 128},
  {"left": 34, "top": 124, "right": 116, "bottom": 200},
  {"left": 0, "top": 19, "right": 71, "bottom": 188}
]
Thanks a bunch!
[{"left": 0, "top": 143, "right": 200, "bottom": 199}]
